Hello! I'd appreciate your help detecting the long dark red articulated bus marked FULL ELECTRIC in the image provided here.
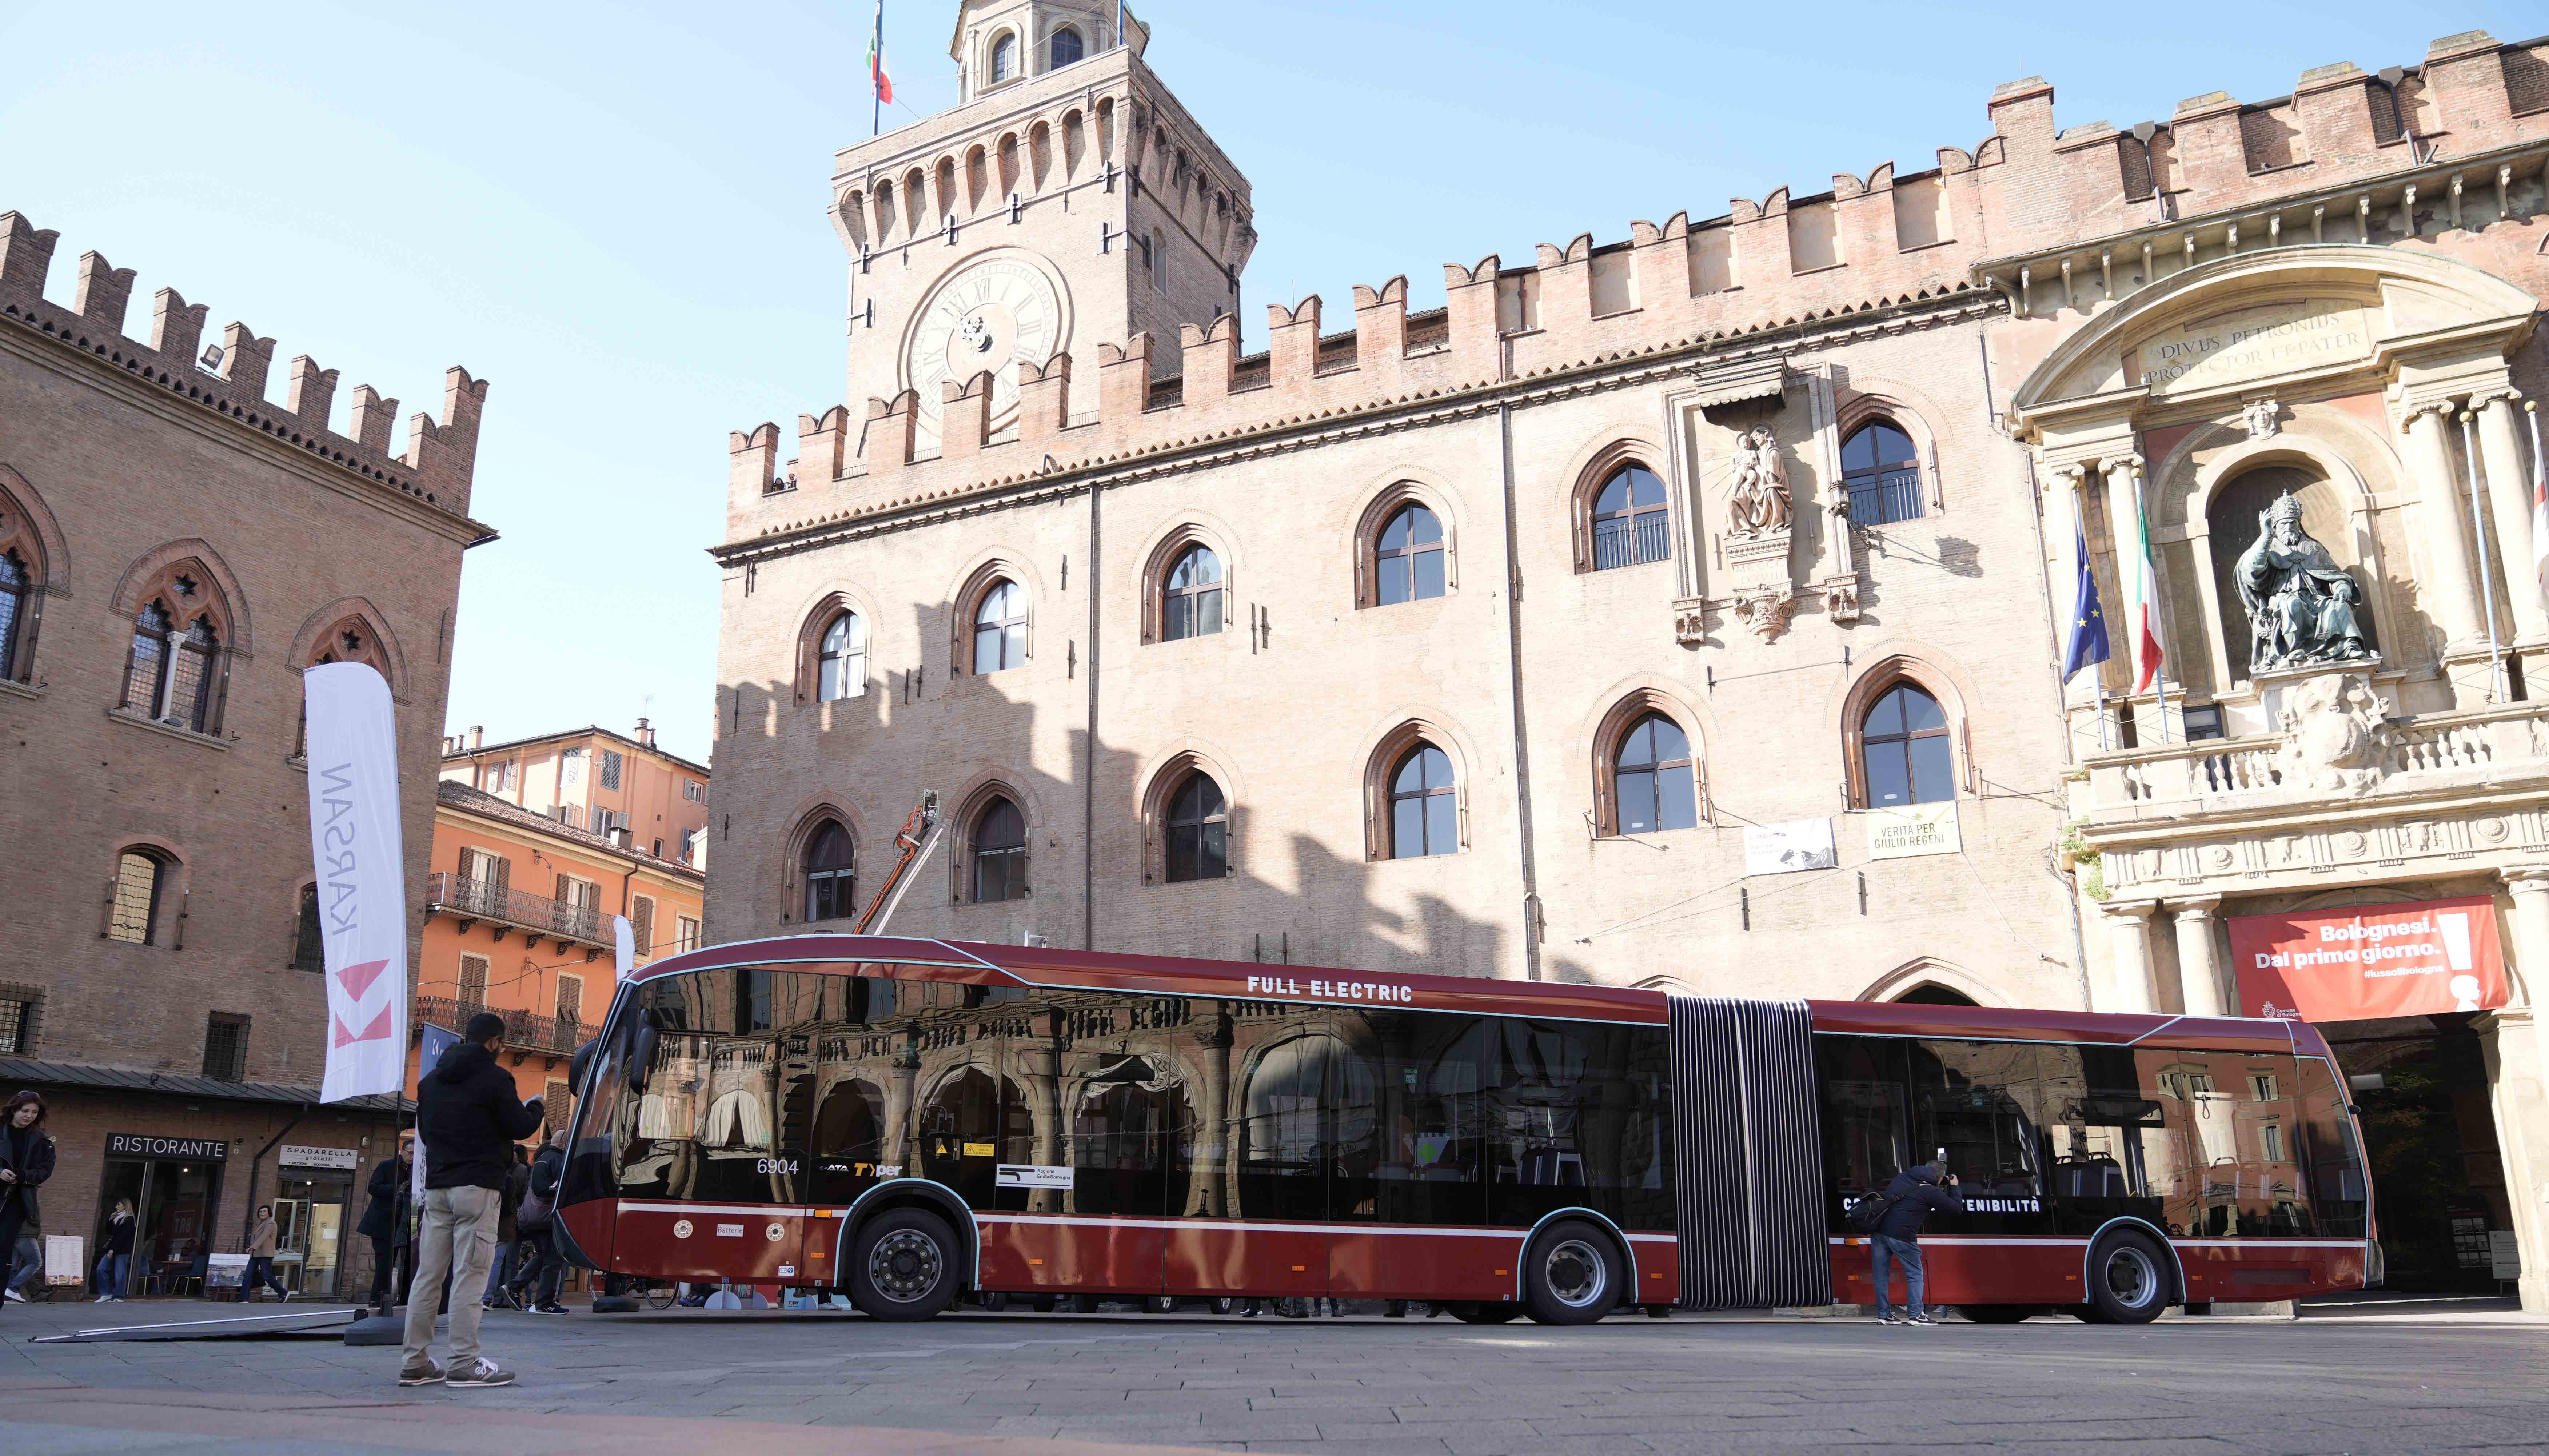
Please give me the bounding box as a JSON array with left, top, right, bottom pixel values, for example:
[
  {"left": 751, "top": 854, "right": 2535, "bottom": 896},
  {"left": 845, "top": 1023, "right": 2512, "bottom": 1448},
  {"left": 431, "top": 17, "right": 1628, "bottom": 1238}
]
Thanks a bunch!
[{"left": 558, "top": 936, "right": 2373, "bottom": 1323}]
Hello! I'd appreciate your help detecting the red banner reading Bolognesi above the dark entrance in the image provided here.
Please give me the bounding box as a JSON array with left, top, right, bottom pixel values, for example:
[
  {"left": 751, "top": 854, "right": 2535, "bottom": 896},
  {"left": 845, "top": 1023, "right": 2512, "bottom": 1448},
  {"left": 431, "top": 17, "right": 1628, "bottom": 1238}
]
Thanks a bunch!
[{"left": 2230, "top": 895, "right": 2511, "bottom": 1022}]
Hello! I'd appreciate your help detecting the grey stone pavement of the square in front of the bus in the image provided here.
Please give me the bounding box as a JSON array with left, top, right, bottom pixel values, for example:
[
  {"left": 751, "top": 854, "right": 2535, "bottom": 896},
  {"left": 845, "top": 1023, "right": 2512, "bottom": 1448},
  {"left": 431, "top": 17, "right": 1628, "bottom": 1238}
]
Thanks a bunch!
[{"left": 0, "top": 1305, "right": 2549, "bottom": 1456}]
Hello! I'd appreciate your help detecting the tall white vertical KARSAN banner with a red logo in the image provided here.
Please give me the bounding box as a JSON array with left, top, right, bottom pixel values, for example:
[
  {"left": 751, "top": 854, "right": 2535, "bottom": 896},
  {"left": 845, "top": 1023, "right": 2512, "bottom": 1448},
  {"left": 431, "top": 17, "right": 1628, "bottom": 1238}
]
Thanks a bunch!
[{"left": 301, "top": 663, "right": 408, "bottom": 1102}]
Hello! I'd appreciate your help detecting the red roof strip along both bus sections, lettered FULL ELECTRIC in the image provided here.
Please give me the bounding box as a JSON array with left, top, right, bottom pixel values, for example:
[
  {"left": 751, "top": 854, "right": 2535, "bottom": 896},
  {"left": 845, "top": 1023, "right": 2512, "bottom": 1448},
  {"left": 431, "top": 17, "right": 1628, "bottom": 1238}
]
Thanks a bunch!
[{"left": 630, "top": 933, "right": 2327, "bottom": 1056}]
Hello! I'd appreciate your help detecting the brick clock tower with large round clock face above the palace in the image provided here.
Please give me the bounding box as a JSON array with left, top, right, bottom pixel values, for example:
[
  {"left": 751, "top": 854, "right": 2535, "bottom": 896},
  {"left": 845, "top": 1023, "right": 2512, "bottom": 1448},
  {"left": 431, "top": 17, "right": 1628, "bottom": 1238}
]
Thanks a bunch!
[{"left": 831, "top": 0, "right": 1257, "bottom": 454}]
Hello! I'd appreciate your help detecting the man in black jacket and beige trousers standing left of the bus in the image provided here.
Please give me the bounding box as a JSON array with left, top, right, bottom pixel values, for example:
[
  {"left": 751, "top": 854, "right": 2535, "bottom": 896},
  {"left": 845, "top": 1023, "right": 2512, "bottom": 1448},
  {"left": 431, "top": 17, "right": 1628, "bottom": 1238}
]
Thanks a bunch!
[{"left": 398, "top": 1012, "right": 540, "bottom": 1390}]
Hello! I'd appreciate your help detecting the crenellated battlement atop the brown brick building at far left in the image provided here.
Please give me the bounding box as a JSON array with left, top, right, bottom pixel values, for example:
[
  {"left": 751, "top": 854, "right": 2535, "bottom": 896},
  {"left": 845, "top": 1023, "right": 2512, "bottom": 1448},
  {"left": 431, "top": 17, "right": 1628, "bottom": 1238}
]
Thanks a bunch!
[{"left": 0, "top": 212, "right": 487, "bottom": 515}]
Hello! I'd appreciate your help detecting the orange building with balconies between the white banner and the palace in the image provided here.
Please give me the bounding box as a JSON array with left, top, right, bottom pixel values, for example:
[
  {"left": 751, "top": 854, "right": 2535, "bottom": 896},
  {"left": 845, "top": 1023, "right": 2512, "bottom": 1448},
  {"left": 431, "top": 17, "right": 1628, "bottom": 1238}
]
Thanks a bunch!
[{"left": 408, "top": 722, "right": 709, "bottom": 1135}]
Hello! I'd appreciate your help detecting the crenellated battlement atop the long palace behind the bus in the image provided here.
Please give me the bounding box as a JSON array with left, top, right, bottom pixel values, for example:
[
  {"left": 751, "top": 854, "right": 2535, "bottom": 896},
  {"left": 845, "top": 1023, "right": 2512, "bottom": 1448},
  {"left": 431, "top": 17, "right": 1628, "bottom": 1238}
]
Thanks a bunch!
[{"left": 729, "top": 31, "right": 2549, "bottom": 543}]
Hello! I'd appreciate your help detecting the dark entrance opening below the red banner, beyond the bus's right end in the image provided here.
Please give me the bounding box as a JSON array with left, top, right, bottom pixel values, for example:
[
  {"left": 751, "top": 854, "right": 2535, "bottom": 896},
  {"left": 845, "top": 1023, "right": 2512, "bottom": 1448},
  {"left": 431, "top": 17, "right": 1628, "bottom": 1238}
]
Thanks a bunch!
[{"left": 2319, "top": 1012, "right": 2513, "bottom": 1293}]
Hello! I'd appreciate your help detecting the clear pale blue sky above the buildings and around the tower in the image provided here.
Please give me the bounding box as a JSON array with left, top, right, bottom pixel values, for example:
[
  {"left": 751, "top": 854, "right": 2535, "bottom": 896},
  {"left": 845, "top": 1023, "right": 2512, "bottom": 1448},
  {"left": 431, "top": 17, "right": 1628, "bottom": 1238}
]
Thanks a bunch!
[{"left": 0, "top": 0, "right": 2549, "bottom": 755}]
